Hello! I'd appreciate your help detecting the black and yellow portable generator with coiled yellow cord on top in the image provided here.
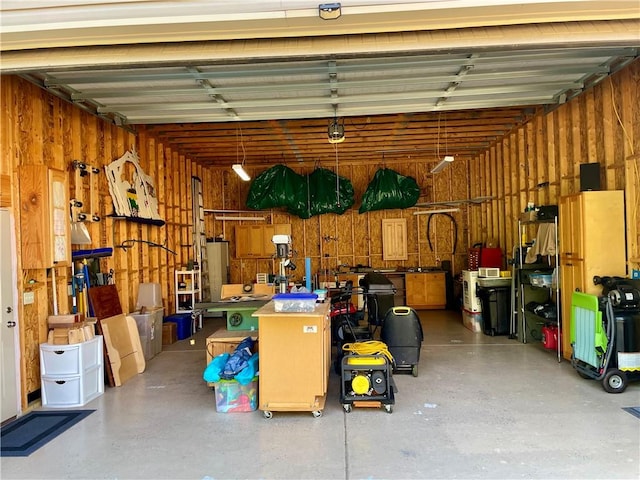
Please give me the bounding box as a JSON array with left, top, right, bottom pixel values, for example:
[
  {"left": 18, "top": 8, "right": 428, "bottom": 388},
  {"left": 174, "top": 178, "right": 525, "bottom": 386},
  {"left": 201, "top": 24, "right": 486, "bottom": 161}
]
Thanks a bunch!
[{"left": 340, "top": 350, "right": 395, "bottom": 413}]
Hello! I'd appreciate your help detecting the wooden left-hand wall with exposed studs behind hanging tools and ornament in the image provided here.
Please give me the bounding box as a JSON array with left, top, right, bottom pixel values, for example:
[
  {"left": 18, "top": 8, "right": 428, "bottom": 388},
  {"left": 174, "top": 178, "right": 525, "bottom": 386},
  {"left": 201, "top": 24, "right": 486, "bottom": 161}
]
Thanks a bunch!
[{"left": 0, "top": 76, "right": 196, "bottom": 408}]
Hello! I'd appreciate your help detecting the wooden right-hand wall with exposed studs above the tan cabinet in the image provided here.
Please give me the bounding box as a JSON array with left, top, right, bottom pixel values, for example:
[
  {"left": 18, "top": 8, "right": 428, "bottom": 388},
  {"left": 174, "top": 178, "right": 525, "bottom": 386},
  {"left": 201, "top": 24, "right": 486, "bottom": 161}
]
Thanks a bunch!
[{"left": 469, "top": 60, "right": 640, "bottom": 270}]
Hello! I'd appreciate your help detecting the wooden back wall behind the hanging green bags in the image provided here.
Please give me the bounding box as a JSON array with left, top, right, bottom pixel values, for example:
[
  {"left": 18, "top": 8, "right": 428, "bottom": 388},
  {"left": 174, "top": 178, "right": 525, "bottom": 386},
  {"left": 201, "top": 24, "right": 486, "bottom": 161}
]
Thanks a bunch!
[{"left": 185, "top": 161, "right": 468, "bottom": 283}]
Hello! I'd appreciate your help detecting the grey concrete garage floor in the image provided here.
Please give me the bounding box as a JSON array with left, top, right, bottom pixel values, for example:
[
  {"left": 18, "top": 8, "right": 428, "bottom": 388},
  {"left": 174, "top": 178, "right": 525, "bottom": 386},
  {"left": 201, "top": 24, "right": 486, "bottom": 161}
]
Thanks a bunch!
[{"left": 0, "top": 311, "right": 640, "bottom": 480}]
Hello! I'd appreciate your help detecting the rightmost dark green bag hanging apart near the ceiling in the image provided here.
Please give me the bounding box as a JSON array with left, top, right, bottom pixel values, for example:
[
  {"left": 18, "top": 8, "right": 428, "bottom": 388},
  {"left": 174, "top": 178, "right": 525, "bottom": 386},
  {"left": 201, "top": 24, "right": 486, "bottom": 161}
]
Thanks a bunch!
[{"left": 358, "top": 168, "right": 420, "bottom": 213}]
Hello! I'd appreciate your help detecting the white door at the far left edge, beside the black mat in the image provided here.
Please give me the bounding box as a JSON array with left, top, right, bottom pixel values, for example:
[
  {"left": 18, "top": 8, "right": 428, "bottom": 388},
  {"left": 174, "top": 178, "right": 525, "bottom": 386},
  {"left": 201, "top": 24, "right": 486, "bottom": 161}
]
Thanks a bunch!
[{"left": 0, "top": 209, "right": 19, "bottom": 422}]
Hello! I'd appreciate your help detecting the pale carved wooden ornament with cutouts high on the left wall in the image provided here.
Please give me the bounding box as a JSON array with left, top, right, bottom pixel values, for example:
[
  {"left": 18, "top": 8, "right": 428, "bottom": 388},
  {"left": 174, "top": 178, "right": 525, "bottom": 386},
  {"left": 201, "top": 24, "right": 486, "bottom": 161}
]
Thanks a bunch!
[{"left": 104, "top": 149, "right": 164, "bottom": 223}]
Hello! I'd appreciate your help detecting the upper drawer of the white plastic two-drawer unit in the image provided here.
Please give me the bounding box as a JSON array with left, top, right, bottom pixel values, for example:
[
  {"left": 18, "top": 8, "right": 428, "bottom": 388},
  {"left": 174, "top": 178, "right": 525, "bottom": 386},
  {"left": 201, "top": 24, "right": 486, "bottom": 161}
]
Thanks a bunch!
[{"left": 40, "top": 336, "right": 102, "bottom": 375}]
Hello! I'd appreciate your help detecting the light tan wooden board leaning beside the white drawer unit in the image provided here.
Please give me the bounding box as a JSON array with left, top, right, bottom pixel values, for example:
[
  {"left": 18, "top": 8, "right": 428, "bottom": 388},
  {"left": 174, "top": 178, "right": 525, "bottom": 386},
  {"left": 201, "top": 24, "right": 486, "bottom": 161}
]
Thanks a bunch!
[{"left": 100, "top": 315, "right": 146, "bottom": 387}]
